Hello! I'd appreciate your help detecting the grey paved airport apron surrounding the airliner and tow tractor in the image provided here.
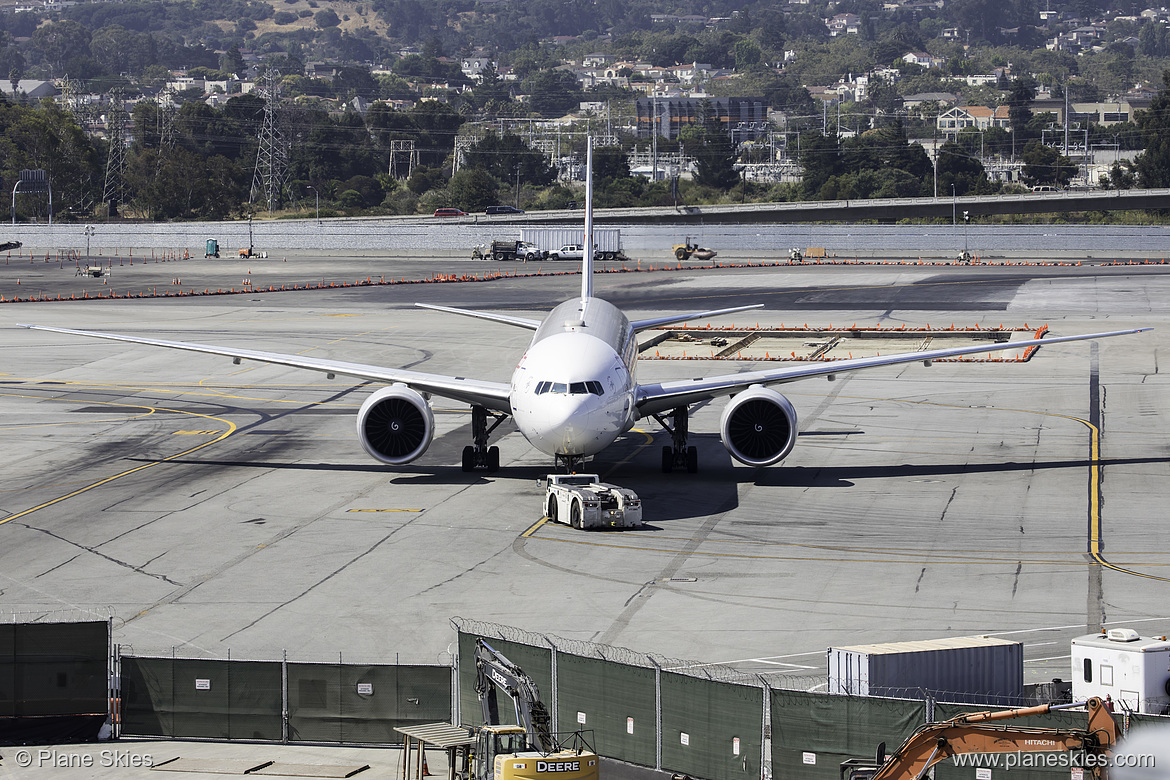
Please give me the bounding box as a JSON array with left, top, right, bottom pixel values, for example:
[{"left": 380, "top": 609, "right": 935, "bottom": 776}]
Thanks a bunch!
[{"left": 0, "top": 254, "right": 1170, "bottom": 776}]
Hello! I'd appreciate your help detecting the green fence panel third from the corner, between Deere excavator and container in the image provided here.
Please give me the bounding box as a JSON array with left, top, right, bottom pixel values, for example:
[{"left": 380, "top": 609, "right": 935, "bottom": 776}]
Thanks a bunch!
[{"left": 662, "top": 672, "right": 764, "bottom": 780}]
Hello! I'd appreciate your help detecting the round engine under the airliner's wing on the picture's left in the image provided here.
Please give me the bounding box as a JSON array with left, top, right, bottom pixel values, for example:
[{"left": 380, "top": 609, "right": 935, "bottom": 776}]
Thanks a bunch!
[{"left": 358, "top": 385, "right": 435, "bottom": 465}]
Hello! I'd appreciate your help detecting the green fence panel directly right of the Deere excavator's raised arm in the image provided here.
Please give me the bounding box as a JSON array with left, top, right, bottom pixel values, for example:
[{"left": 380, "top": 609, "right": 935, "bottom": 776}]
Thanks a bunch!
[{"left": 545, "top": 653, "right": 656, "bottom": 766}]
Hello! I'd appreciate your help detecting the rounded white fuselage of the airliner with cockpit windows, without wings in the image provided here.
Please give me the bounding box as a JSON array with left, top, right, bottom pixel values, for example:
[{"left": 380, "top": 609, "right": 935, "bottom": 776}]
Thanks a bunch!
[{"left": 510, "top": 297, "right": 638, "bottom": 455}]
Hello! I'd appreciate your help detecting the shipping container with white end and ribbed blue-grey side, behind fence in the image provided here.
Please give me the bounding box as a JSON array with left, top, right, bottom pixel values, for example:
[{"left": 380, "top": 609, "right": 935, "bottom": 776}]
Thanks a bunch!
[{"left": 828, "top": 636, "right": 1024, "bottom": 706}]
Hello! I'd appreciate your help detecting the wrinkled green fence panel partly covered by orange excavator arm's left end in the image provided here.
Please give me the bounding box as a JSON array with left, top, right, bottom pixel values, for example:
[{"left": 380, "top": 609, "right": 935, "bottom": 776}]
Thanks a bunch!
[{"left": 770, "top": 690, "right": 925, "bottom": 780}]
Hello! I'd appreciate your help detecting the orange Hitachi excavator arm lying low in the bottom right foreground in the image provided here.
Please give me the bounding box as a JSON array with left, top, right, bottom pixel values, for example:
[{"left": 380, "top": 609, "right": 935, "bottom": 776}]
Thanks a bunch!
[{"left": 841, "top": 697, "right": 1119, "bottom": 780}]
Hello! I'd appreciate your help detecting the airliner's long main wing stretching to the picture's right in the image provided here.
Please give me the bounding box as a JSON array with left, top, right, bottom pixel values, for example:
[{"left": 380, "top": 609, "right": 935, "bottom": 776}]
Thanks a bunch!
[{"left": 638, "top": 327, "right": 1151, "bottom": 416}]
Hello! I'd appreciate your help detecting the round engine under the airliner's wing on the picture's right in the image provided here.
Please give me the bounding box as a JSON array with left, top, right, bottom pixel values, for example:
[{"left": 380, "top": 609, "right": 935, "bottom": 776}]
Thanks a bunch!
[{"left": 720, "top": 385, "right": 797, "bottom": 465}]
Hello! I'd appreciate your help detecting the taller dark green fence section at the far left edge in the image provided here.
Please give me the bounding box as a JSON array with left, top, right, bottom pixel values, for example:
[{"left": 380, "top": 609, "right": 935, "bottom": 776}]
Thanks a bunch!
[{"left": 0, "top": 621, "right": 110, "bottom": 717}]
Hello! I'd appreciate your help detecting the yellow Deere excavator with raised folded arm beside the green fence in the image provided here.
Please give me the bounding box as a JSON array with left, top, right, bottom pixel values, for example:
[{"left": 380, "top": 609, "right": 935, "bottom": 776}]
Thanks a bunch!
[{"left": 470, "top": 639, "right": 599, "bottom": 780}]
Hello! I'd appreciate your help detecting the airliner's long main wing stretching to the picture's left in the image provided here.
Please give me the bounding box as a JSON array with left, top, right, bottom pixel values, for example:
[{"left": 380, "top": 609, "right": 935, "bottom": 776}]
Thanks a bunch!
[{"left": 18, "top": 324, "right": 511, "bottom": 414}]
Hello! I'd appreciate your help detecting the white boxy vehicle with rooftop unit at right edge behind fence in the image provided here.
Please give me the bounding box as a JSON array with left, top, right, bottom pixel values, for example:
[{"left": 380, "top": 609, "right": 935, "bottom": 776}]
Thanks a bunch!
[{"left": 1073, "top": 628, "right": 1170, "bottom": 715}]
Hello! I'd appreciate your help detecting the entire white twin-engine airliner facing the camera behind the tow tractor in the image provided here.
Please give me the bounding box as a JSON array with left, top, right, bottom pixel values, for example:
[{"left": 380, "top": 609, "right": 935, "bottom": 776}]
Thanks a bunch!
[{"left": 25, "top": 145, "right": 1150, "bottom": 472}]
